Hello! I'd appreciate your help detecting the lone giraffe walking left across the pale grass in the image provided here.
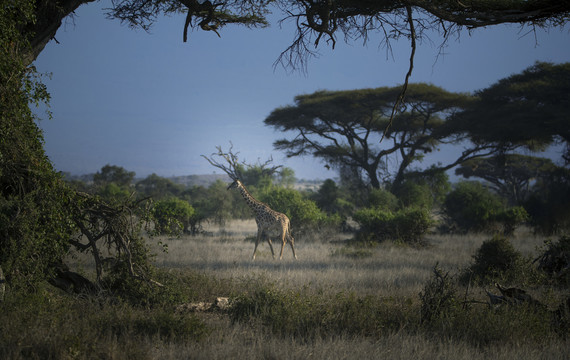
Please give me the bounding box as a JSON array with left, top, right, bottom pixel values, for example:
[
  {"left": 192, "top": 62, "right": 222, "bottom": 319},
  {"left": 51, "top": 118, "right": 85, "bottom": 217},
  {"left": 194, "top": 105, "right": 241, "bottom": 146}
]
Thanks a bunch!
[{"left": 228, "top": 179, "right": 297, "bottom": 260}]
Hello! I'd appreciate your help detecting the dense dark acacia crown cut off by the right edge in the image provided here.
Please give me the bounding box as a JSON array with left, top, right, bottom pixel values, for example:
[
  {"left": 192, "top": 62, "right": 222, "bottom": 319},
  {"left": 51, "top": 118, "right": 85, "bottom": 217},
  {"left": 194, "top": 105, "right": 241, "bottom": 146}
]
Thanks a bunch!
[{"left": 448, "top": 62, "right": 570, "bottom": 164}]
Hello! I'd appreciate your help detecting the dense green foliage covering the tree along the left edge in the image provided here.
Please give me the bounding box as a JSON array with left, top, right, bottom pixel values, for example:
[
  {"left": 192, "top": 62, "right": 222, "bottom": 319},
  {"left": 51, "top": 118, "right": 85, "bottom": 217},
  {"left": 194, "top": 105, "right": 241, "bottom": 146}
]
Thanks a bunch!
[{"left": 0, "top": 0, "right": 73, "bottom": 287}]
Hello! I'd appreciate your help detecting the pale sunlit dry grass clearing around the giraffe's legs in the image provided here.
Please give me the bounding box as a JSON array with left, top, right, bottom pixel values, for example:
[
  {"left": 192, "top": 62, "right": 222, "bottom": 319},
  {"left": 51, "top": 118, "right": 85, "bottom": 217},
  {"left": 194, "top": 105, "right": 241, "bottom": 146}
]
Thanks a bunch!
[{"left": 149, "top": 220, "right": 543, "bottom": 296}]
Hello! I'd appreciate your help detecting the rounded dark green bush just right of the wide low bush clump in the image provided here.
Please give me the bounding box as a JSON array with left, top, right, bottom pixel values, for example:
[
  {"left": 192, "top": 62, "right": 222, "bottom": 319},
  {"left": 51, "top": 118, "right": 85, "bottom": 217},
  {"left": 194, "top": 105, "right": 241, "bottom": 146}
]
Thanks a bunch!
[{"left": 443, "top": 181, "right": 504, "bottom": 233}]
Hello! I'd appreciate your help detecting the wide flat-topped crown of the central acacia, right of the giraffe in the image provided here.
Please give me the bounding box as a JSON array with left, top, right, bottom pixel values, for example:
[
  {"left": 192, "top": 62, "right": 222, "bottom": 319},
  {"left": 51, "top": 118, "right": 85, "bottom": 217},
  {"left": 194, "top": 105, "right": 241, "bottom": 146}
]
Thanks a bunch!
[{"left": 265, "top": 84, "right": 474, "bottom": 188}]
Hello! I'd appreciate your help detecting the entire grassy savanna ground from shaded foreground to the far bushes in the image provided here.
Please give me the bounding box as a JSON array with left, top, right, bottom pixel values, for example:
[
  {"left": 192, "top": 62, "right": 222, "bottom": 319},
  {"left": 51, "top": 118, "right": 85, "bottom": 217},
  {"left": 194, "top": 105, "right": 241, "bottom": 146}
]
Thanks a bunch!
[{"left": 0, "top": 220, "right": 570, "bottom": 359}]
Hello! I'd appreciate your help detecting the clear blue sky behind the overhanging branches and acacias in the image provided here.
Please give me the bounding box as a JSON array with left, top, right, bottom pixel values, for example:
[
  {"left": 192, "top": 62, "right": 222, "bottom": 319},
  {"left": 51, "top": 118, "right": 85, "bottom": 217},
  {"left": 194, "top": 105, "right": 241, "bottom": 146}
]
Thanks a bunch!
[{"left": 35, "top": 1, "right": 570, "bottom": 179}]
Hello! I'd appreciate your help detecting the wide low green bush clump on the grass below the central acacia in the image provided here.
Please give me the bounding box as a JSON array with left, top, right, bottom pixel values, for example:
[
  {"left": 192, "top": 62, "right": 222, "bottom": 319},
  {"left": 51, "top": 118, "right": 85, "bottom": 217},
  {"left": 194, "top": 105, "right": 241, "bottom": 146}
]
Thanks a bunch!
[{"left": 354, "top": 208, "right": 433, "bottom": 244}]
